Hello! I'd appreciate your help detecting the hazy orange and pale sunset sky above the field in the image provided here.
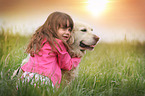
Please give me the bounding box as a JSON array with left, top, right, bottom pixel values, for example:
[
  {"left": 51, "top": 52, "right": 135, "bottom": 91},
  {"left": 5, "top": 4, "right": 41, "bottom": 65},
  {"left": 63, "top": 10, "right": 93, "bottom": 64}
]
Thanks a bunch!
[{"left": 0, "top": 0, "right": 145, "bottom": 41}]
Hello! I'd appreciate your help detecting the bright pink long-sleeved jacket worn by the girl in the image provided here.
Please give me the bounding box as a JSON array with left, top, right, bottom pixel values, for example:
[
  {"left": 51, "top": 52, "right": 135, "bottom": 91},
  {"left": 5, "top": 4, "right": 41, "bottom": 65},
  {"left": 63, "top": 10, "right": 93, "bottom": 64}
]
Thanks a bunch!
[{"left": 21, "top": 39, "right": 81, "bottom": 85}]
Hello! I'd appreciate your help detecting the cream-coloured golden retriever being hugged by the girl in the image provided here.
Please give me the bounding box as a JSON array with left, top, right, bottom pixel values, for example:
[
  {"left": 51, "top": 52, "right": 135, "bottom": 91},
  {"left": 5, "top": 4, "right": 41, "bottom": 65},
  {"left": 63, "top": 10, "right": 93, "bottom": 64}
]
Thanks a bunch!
[{"left": 11, "top": 22, "right": 99, "bottom": 84}]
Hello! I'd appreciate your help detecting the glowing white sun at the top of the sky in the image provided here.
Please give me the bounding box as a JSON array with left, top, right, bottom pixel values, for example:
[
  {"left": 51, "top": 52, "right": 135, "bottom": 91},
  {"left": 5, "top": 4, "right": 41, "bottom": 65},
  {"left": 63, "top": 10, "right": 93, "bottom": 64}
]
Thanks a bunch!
[{"left": 87, "top": 0, "right": 109, "bottom": 16}]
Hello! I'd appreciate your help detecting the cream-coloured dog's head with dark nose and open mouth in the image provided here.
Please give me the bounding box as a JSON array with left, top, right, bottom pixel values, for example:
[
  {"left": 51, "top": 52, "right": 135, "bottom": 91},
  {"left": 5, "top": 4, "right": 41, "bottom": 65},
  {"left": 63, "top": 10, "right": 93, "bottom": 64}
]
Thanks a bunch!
[{"left": 68, "top": 22, "right": 99, "bottom": 57}]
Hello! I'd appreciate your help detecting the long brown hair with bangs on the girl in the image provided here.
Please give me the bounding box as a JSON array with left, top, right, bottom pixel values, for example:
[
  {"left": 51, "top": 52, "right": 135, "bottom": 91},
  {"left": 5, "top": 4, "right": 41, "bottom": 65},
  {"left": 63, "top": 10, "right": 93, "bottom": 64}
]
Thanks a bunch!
[{"left": 26, "top": 12, "right": 74, "bottom": 57}]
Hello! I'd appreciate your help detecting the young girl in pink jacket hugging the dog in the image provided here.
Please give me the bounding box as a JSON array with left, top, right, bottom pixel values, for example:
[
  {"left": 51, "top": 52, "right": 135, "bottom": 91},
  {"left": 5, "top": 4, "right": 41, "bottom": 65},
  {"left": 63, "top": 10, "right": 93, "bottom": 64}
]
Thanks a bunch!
[{"left": 21, "top": 12, "right": 81, "bottom": 87}]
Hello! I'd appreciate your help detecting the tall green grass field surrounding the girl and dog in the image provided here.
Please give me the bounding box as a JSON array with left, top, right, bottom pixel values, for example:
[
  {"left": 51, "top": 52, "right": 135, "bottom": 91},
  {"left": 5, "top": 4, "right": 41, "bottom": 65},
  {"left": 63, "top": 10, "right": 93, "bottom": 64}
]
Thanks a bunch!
[{"left": 0, "top": 33, "right": 145, "bottom": 96}]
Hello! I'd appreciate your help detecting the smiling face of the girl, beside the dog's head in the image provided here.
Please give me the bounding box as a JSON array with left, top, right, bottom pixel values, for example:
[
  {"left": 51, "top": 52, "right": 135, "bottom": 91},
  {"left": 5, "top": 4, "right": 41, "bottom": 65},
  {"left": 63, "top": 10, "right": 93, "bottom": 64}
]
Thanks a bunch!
[{"left": 57, "top": 27, "right": 71, "bottom": 42}]
